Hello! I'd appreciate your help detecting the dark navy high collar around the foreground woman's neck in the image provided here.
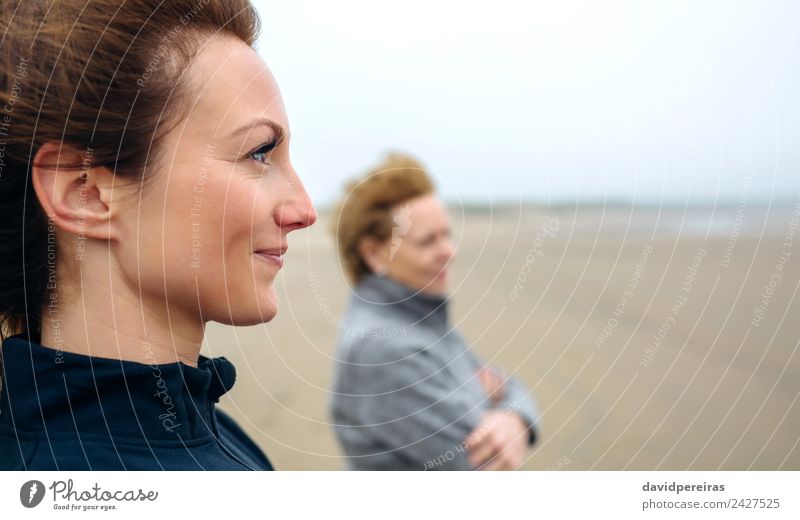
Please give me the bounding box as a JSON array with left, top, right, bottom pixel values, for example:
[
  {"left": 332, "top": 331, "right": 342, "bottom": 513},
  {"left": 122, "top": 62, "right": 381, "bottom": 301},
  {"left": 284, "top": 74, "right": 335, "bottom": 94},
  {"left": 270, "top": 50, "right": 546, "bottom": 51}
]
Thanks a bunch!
[{"left": 0, "top": 334, "right": 236, "bottom": 441}]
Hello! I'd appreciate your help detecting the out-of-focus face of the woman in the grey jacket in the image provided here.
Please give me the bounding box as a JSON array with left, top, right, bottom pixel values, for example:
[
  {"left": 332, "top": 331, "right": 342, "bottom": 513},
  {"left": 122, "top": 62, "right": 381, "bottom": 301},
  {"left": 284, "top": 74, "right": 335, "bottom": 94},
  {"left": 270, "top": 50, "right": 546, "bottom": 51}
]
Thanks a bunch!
[{"left": 383, "top": 194, "right": 455, "bottom": 295}]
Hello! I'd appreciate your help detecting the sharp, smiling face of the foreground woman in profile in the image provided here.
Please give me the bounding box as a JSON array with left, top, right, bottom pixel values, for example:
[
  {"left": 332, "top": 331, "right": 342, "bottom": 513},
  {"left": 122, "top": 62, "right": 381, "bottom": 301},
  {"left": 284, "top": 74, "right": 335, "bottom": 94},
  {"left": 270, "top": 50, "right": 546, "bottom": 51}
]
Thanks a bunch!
[{"left": 116, "top": 36, "right": 317, "bottom": 325}]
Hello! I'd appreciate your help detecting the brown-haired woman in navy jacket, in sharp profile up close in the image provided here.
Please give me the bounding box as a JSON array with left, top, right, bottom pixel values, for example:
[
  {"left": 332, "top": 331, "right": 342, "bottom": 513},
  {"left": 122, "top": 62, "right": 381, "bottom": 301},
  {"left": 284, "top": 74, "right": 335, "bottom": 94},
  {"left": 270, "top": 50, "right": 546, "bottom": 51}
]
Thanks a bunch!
[{"left": 0, "top": 0, "right": 316, "bottom": 470}]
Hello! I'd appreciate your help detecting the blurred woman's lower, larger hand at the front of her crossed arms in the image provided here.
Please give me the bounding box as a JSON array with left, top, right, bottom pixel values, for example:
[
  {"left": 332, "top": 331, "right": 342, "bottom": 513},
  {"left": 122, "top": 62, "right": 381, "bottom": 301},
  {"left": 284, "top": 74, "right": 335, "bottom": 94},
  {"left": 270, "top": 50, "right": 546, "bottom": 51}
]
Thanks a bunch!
[{"left": 466, "top": 410, "right": 528, "bottom": 470}]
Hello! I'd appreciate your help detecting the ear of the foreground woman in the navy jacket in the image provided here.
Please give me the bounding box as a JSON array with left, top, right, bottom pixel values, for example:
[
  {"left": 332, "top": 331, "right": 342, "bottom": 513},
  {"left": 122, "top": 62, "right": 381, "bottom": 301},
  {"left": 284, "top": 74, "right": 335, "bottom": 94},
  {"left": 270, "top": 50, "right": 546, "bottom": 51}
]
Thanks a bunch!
[{"left": 31, "top": 141, "right": 128, "bottom": 240}]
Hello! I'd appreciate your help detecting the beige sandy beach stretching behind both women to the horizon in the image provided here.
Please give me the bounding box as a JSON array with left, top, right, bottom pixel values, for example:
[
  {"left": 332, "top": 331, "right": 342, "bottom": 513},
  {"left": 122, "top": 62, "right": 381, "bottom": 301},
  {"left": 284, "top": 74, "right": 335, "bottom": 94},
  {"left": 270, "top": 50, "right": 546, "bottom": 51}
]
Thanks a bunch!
[{"left": 203, "top": 203, "right": 800, "bottom": 470}]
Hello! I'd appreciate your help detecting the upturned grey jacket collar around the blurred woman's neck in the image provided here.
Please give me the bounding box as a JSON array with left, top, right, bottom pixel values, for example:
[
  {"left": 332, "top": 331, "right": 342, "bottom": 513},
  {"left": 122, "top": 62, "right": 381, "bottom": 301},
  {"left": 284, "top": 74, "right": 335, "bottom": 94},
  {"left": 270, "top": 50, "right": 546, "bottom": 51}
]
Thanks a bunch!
[{"left": 355, "top": 273, "right": 449, "bottom": 329}]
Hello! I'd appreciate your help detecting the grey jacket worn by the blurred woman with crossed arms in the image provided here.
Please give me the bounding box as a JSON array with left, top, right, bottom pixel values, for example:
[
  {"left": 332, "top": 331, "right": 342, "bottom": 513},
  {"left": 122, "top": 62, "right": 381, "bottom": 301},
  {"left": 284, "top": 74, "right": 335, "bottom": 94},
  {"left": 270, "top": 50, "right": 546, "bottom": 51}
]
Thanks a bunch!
[{"left": 329, "top": 275, "right": 539, "bottom": 470}]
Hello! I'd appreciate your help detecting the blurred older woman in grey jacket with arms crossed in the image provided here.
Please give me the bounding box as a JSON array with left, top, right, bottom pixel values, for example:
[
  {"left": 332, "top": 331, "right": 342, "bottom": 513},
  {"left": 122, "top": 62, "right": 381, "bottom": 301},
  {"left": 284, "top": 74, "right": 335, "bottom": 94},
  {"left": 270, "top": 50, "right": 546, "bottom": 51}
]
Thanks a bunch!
[{"left": 330, "top": 154, "right": 537, "bottom": 470}]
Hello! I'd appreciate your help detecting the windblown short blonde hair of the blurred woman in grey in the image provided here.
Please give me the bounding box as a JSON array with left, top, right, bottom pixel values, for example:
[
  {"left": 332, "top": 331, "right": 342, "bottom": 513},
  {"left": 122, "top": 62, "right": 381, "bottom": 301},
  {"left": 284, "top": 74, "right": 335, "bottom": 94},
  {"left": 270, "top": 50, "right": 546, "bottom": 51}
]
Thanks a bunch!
[{"left": 331, "top": 152, "right": 435, "bottom": 283}]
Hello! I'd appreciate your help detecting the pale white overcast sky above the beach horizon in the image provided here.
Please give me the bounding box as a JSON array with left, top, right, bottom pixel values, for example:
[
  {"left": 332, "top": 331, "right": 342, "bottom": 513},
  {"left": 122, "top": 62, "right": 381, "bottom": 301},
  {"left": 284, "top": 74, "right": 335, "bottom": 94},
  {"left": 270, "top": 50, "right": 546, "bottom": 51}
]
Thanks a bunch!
[{"left": 254, "top": 0, "right": 800, "bottom": 204}]
